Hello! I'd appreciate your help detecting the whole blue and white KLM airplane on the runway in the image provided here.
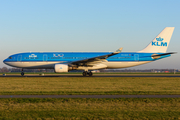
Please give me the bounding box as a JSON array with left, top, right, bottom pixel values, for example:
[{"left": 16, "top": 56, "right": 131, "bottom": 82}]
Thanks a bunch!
[{"left": 3, "top": 27, "right": 174, "bottom": 76}]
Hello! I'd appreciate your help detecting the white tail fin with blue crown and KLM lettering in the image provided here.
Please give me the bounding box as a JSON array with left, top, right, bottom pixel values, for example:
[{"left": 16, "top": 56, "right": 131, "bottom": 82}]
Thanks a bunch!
[{"left": 139, "top": 27, "right": 174, "bottom": 53}]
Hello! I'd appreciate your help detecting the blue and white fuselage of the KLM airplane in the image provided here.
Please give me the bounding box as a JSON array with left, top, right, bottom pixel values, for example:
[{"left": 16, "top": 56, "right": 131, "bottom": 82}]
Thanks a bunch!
[{"left": 3, "top": 52, "right": 171, "bottom": 69}]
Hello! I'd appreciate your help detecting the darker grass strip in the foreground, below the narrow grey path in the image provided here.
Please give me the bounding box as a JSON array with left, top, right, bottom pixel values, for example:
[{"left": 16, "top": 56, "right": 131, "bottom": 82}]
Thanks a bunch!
[{"left": 0, "top": 98, "right": 180, "bottom": 120}]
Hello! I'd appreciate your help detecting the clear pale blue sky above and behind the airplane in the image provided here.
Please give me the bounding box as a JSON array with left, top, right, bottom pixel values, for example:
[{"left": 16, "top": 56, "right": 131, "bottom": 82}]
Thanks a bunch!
[{"left": 0, "top": 0, "right": 180, "bottom": 69}]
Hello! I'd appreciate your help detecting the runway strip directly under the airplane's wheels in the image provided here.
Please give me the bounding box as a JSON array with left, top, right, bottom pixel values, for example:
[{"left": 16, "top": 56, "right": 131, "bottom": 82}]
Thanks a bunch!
[{"left": 0, "top": 74, "right": 180, "bottom": 77}]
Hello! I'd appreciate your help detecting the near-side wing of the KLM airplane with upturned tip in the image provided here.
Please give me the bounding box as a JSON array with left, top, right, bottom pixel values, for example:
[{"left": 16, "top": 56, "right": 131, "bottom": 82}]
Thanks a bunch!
[{"left": 70, "top": 48, "right": 123, "bottom": 65}]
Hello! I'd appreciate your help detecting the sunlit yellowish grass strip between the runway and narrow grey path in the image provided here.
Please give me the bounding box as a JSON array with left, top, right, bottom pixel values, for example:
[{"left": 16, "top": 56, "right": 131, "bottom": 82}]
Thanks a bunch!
[{"left": 0, "top": 77, "right": 180, "bottom": 95}]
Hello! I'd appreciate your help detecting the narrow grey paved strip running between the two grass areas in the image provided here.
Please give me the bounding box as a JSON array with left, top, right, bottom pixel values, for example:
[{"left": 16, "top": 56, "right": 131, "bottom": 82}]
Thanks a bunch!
[{"left": 0, "top": 95, "right": 180, "bottom": 99}]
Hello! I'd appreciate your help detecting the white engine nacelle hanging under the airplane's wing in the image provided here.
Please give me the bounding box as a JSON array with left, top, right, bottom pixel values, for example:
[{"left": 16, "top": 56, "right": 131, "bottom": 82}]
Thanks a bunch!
[{"left": 54, "top": 64, "right": 68, "bottom": 73}]
